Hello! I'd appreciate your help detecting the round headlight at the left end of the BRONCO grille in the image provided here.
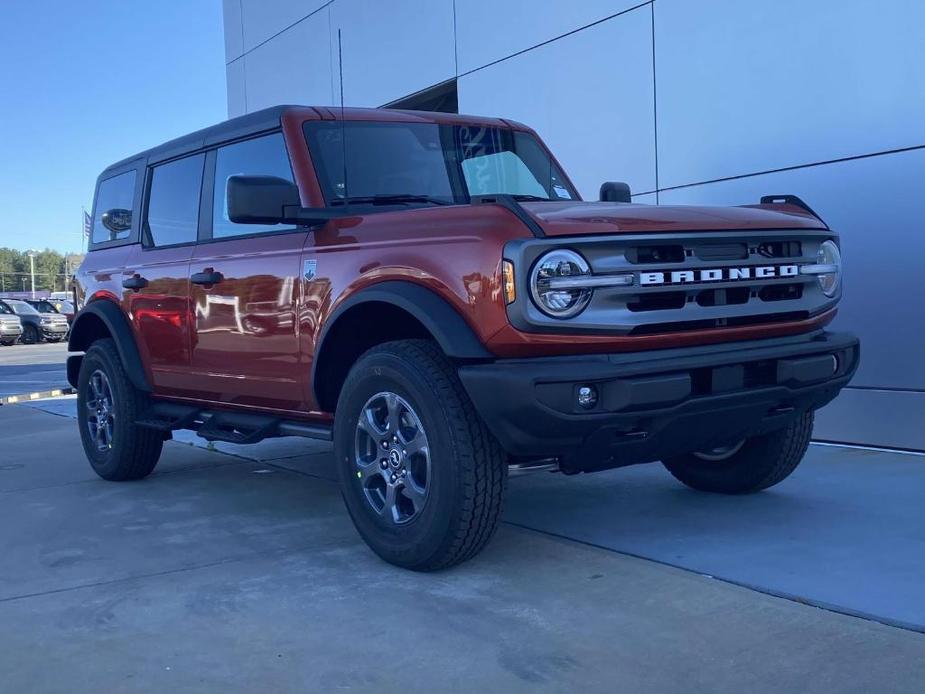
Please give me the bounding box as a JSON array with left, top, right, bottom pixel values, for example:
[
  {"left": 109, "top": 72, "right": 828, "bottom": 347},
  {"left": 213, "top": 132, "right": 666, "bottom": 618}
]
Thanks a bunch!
[{"left": 530, "top": 250, "right": 591, "bottom": 318}]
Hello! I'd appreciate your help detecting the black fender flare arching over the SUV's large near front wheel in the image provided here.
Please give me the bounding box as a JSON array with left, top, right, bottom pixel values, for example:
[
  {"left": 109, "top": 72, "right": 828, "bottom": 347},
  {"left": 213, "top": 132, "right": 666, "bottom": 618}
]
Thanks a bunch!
[{"left": 312, "top": 280, "right": 494, "bottom": 396}]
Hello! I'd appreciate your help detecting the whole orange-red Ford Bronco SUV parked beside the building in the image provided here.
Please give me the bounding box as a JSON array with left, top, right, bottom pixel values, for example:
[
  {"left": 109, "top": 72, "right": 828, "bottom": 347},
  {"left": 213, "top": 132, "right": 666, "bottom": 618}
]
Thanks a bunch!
[{"left": 68, "top": 106, "right": 859, "bottom": 570}]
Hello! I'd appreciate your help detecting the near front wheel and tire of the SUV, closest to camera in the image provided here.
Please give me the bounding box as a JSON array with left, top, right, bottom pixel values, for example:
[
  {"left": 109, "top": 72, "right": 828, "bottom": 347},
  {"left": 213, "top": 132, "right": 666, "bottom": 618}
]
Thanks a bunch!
[{"left": 334, "top": 340, "right": 507, "bottom": 571}]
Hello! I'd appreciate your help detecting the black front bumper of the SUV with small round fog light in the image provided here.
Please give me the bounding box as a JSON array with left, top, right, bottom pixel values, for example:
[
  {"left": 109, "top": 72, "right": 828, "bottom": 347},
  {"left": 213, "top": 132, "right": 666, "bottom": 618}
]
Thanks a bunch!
[{"left": 459, "top": 331, "right": 860, "bottom": 472}]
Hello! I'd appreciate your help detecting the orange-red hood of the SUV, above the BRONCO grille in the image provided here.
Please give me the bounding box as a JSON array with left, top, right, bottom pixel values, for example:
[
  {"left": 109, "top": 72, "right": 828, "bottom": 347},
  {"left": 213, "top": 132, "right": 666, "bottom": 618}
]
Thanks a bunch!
[{"left": 521, "top": 201, "right": 826, "bottom": 236}]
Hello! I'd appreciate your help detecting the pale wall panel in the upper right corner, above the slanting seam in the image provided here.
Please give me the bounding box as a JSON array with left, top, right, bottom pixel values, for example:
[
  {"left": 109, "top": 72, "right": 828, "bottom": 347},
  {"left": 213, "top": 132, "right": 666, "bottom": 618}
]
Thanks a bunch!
[{"left": 652, "top": 0, "right": 925, "bottom": 187}]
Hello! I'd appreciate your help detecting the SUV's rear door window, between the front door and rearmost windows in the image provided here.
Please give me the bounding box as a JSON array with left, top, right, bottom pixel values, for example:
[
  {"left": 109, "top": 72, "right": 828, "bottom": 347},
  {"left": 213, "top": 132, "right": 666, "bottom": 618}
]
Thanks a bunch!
[{"left": 145, "top": 154, "right": 205, "bottom": 246}]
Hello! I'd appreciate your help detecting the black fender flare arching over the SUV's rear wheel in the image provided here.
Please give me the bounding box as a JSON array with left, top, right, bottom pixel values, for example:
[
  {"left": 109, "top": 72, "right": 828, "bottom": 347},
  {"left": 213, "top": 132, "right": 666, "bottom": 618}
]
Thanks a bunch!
[{"left": 67, "top": 299, "right": 151, "bottom": 393}]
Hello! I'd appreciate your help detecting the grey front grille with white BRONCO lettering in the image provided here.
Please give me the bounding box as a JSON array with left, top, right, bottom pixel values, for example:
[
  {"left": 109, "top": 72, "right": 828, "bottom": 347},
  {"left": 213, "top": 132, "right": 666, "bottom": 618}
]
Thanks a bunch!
[{"left": 508, "top": 229, "right": 836, "bottom": 335}]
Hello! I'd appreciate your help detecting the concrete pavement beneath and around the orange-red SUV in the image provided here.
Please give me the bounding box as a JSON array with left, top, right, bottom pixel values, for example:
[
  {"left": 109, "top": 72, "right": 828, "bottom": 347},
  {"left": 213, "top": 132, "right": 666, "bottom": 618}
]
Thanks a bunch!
[{"left": 0, "top": 352, "right": 925, "bottom": 692}]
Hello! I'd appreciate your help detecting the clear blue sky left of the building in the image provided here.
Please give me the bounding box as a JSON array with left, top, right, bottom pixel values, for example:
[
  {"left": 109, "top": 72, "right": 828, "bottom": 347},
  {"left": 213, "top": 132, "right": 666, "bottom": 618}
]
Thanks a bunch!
[{"left": 0, "top": 0, "right": 227, "bottom": 251}]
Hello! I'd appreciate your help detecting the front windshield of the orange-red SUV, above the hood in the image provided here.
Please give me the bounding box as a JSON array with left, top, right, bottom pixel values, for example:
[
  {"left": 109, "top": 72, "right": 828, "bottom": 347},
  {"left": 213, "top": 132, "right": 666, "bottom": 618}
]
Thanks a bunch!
[{"left": 305, "top": 121, "right": 578, "bottom": 205}]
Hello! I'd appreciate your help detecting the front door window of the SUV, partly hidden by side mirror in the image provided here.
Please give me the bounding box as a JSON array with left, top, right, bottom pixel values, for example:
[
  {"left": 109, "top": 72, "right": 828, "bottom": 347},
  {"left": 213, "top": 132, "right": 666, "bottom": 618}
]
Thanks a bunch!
[{"left": 212, "top": 133, "right": 294, "bottom": 239}]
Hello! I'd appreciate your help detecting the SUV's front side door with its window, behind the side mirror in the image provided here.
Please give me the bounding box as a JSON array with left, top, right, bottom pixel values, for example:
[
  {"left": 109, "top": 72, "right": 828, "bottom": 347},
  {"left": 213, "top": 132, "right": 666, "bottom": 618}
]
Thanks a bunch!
[{"left": 190, "top": 133, "right": 307, "bottom": 411}]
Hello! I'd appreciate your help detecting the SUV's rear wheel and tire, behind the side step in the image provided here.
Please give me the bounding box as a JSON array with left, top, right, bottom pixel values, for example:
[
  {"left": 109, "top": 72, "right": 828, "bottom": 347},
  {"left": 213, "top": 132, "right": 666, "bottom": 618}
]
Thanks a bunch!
[{"left": 77, "top": 339, "right": 164, "bottom": 481}]
